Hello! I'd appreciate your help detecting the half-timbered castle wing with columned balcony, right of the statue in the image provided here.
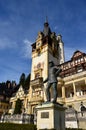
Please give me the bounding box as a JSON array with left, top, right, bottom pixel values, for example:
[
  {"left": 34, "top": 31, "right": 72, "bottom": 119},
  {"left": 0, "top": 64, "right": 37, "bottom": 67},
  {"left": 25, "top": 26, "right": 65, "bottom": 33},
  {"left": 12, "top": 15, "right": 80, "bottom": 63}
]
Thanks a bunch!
[{"left": 58, "top": 50, "right": 86, "bottom": 111}]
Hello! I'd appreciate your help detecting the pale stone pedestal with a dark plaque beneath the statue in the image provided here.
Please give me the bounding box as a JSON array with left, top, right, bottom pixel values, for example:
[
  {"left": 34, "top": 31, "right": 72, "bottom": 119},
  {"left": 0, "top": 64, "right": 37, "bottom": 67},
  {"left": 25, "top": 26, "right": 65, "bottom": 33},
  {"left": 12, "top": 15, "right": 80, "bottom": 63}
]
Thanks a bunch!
[{"left": 36, "top": 103, "right": 65, "bottom": 130}]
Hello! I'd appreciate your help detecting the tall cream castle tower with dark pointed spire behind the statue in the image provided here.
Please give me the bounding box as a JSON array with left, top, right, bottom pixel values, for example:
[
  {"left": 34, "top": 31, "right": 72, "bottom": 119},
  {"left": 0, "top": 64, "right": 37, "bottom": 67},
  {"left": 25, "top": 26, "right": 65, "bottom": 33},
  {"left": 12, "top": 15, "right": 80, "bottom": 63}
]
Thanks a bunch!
[{"left": 29, "top": 21, "right": 64, "bottom": 113}]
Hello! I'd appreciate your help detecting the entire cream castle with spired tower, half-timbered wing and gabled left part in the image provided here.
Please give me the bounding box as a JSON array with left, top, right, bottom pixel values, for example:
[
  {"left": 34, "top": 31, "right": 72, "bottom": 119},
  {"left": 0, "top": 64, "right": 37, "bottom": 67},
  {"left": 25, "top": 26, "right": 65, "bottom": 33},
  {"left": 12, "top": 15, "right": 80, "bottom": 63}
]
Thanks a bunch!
[{"left": 0, "top": 21, "right": 86, "bottom": 114}]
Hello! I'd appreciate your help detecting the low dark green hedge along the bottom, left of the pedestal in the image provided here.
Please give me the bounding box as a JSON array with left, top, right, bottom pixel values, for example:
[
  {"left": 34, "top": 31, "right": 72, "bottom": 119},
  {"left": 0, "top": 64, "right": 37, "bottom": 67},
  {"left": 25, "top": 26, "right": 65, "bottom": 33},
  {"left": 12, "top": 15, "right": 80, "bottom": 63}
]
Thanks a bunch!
[{"left": 0, "top": 123, "right": 36, "bottom": 130}]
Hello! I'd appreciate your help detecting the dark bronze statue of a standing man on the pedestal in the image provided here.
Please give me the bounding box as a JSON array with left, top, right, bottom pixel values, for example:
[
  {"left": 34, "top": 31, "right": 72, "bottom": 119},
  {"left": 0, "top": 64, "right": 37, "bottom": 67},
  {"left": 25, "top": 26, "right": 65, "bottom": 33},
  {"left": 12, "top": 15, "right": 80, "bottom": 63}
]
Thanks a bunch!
[{"left": 43, "top": 61, "right": 62, "bottom": 103}]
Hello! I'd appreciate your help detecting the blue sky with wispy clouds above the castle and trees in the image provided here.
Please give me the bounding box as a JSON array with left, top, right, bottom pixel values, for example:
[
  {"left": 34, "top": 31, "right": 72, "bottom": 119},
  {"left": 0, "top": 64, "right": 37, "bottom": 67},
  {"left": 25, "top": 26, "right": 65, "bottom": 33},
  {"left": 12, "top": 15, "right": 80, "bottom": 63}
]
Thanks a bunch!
[{"left": 0, "top": 0, "right": 86, "bottom": 83}]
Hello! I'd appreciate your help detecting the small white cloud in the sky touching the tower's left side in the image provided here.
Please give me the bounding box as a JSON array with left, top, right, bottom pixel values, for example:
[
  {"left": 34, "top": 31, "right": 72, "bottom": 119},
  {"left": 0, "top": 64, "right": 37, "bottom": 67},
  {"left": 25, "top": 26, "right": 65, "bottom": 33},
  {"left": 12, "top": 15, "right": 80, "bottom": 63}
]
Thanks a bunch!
[{"left": 22, "top": 39, "right": 32, "bottom": 58}]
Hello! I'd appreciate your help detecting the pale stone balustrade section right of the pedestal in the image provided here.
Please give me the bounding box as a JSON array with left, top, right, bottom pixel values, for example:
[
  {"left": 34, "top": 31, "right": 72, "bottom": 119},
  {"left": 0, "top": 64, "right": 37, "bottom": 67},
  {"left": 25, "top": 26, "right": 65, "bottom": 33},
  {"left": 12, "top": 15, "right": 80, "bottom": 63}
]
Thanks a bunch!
[{"left": 65, "top": 111, "right": 86, "bottom": 129}]
